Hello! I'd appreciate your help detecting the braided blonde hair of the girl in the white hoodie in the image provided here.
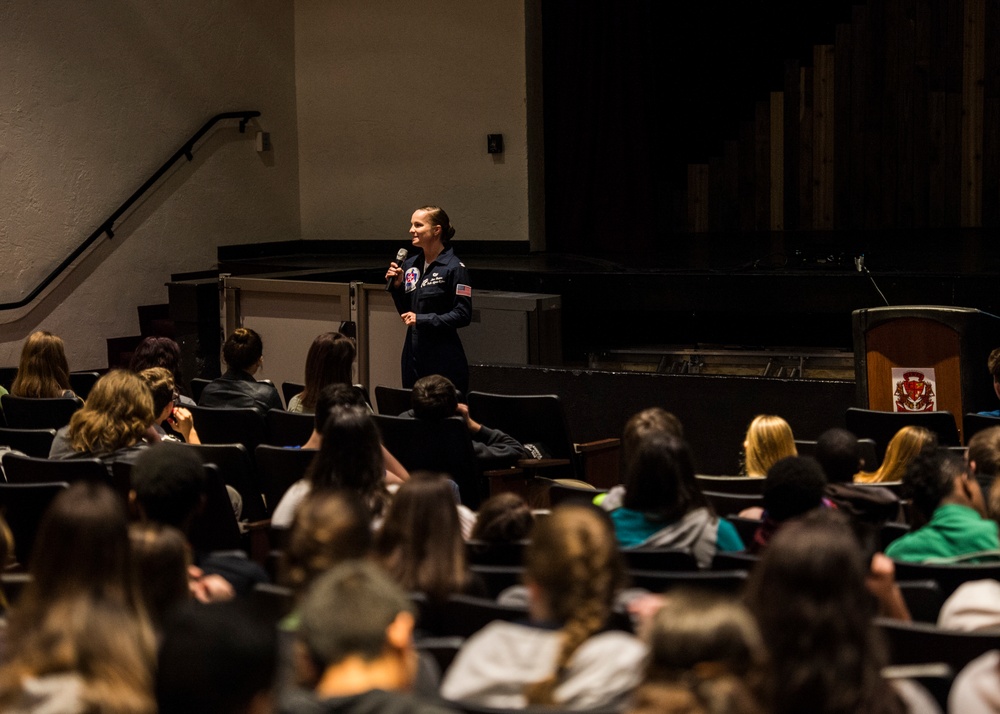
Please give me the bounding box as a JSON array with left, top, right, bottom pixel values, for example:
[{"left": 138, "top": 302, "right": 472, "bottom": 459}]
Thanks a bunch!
[{"left": 524, "top": 505, "right": 624, "bottom": 705}]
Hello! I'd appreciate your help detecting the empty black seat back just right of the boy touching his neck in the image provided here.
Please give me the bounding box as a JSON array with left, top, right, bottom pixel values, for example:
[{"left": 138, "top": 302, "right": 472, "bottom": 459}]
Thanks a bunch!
[{"left": 469, "top": 392, "right": 577, "bottom": 463}]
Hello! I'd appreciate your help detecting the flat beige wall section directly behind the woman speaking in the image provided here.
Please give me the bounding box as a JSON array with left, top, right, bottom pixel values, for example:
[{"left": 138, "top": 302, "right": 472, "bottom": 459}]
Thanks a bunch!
[{"left": 295, "top": 0, "right": 541, "bottom": 243}]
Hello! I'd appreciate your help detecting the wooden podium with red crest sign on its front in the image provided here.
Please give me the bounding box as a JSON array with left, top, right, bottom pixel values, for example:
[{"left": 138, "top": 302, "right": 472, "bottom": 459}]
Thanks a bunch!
[{"left": 852, "top": 305, "right": 1000, "bottom": 434}]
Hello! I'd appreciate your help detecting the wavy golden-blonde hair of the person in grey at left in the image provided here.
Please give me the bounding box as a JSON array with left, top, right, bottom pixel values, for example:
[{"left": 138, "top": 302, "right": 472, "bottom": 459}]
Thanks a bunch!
[{"left": 68, "top": 369, "right": 156, "bottom": 454}]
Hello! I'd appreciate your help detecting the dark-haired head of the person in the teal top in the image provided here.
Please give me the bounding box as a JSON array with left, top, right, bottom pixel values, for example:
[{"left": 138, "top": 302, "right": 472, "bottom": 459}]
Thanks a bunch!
[{"left": 623, "top": 431, "right": 711, "bottom": 521}]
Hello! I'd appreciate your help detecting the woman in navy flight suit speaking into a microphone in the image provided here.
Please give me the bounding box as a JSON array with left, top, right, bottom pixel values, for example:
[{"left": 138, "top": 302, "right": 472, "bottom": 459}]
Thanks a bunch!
[{"left": 385, "top": 206, "right": 472, "bottom": 394}]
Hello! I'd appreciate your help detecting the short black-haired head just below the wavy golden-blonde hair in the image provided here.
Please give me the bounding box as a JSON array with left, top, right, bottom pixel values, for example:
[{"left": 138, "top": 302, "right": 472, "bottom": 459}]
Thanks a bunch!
[{"left": 132, "top": 444, "right": 205, "bottom": 531}]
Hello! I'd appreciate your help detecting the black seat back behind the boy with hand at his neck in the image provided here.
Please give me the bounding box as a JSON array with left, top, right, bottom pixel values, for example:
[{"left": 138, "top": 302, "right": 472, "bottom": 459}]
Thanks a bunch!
[{"left": 374, "top": 414, "right": 488, "bottom": 510}]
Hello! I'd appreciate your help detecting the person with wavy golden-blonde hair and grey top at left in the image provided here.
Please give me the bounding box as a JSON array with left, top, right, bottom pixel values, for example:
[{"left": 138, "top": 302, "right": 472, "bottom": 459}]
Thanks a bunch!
[{"left": 49, "top": 369, "right": 155, "bottom": 469}]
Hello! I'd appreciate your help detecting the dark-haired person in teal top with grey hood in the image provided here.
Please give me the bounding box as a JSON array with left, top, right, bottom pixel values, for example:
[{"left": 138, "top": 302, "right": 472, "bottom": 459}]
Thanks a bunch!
[{"left": 595, "top": 431, "right": 744, "bottom": 568}]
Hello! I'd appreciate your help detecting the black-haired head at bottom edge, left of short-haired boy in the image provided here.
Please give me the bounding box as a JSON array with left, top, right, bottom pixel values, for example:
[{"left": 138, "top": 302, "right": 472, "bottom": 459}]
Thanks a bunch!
[{"left": 156, "top": 603, "right": 278, "bottom": 714}]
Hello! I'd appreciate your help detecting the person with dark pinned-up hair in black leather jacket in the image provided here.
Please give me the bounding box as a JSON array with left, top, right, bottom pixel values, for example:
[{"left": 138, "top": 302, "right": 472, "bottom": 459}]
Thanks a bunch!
[{"left": 198, "top": 327, "right": 282, "bottom": 415}]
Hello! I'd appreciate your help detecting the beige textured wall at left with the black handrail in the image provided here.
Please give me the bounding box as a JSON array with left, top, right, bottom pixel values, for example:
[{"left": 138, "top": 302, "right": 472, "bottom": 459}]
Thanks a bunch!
[{"left": 0, "top": 0, "right": 299, "bottom": 369}]
